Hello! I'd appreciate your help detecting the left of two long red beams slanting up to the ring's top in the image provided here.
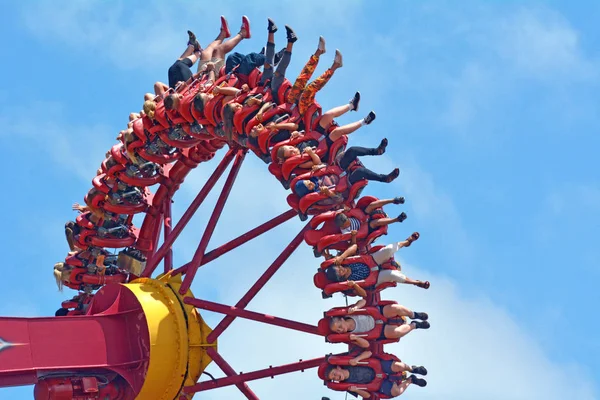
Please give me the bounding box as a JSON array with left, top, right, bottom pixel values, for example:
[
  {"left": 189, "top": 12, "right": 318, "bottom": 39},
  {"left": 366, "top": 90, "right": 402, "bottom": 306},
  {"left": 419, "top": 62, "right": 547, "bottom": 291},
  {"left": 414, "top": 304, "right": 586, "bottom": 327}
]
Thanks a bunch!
[{"left": 142, "top": 149, "right": 235, "bottom": 277}]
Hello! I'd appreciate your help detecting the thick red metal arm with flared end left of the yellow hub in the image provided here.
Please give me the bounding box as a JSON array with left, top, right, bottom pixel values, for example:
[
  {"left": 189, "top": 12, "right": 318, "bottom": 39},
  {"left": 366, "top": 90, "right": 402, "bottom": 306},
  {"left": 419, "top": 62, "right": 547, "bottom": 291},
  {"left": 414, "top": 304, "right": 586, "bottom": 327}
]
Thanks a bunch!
[{"left": 0, "top": 285, "right": 145, "bottom": 398}]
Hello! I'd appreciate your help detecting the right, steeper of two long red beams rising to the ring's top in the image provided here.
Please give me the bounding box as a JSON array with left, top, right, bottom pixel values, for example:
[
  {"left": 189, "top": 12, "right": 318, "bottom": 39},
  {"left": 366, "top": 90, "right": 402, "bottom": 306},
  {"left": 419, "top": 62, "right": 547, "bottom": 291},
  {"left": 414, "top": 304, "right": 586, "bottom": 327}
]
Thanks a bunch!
[{"left": 179, "top": 150, "right": 246, "bottom": 294}]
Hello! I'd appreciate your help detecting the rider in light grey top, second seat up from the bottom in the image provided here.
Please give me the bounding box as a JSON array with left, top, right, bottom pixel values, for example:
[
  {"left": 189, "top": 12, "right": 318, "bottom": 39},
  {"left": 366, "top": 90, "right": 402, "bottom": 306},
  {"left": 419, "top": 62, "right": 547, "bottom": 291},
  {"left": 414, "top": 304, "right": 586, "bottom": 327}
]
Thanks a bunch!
[{"left": 329, "top": 299, "right": 430, "bottom": 349}]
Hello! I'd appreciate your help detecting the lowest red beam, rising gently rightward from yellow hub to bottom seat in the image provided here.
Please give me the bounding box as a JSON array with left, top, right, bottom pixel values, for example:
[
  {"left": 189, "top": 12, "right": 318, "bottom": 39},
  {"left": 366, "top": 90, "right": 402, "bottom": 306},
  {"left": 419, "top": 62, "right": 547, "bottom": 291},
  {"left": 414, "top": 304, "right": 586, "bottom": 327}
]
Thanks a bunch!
[{"left": 183, "top": 354, "right": 325, "bottom": 393}]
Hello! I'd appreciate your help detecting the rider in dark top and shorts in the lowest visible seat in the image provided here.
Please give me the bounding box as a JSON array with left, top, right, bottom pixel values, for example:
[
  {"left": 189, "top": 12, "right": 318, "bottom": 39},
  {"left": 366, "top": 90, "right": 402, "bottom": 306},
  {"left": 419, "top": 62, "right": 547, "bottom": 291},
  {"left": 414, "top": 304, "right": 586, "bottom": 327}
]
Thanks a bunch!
[{"left": 325, "top": 351, "right": 427, "bottom": 399}]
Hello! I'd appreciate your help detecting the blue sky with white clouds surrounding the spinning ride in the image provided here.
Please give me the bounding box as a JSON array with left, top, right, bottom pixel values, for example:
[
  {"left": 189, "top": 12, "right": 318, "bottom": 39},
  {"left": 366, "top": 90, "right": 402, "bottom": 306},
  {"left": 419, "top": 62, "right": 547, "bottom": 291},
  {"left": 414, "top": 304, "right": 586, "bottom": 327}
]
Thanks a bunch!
[{"left": 0, "top": 1, "right": 600, "bottom": 400}]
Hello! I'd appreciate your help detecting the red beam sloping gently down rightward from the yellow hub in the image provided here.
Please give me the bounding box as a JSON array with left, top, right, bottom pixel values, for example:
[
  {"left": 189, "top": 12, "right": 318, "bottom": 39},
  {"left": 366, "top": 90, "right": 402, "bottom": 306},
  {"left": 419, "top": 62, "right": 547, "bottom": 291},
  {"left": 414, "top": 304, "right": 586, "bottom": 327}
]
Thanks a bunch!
[{"left": 183, "top": 297, "right": 322, "bottom": 336}]
